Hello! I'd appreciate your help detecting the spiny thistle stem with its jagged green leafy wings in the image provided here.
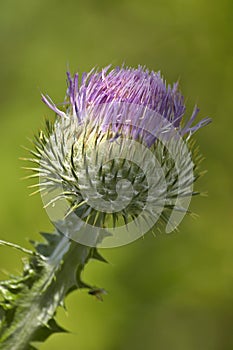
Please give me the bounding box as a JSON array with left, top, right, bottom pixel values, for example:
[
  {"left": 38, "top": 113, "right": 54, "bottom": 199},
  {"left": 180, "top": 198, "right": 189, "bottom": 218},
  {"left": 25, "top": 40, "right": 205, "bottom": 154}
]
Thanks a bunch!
[{"left": 0, "top": 231, "right": 105, "bottom": 350}]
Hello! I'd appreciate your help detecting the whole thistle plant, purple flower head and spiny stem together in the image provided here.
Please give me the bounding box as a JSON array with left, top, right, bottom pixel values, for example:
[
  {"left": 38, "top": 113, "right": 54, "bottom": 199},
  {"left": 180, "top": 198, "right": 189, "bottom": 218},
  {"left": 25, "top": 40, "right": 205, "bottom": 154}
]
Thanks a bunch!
[{"left": 0, "top": 67, "right": 210, "bottom": 350}]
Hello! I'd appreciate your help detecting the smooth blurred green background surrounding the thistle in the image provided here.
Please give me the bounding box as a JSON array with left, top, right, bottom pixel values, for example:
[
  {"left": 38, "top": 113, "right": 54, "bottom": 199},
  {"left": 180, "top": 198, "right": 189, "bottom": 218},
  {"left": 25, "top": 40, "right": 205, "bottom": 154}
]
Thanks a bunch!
[{"left": 0, "top": 0, "right": 233, "bottom": 350}]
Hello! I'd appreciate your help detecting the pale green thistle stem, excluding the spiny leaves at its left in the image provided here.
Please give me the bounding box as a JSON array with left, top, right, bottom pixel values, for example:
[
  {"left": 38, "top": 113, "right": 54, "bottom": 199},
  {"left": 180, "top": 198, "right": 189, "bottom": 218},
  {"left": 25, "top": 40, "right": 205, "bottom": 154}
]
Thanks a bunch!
[{"left": 0, "top": 236, "right": 93, "bottom": 350}]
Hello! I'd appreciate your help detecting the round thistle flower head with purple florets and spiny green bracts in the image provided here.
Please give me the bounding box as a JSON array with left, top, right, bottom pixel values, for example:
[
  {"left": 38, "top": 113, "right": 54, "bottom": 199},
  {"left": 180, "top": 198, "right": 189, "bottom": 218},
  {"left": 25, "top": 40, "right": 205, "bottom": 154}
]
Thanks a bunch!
[{"left": 37, "top": 67, "right": 209, "bottom": 246}]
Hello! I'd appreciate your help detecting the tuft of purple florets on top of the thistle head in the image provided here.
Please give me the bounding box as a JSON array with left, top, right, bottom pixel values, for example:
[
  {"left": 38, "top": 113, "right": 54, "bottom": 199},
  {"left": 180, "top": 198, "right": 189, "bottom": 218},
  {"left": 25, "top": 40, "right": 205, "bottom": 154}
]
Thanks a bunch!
[{"left": 42, "top": 66, "right": 210, "bottom": 146}]
